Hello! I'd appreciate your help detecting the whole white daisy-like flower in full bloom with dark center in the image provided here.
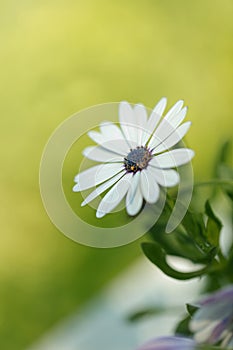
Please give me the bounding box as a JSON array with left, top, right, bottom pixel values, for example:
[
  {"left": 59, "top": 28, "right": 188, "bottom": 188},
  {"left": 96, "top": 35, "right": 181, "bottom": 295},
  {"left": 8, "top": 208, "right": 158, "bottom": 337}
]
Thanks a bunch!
[{"left": 73, "top": 98, "right": 194, "bottom": 218}]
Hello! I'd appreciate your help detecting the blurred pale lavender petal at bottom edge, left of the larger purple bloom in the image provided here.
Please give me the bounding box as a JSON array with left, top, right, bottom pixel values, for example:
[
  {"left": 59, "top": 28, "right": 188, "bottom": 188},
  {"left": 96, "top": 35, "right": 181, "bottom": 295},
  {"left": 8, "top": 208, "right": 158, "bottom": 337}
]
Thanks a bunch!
[{"left": 138, "top": 336, "right": 196, "bottom": 350}]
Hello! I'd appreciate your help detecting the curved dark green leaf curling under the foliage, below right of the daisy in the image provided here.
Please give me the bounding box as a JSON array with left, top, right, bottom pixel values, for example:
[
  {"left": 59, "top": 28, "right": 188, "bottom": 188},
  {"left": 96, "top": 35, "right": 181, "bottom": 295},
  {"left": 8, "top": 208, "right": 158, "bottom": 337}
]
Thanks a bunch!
[{"left": 141, "top": 242, "right": 209, "bottom": 280}]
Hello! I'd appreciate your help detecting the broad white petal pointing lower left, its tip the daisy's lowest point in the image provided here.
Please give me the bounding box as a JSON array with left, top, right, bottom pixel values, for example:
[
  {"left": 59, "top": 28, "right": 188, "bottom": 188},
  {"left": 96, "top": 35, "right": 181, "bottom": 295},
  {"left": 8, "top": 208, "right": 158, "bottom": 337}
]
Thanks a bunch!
[{"left": 96, "top": 173, "right": 133, "bottom": 218}]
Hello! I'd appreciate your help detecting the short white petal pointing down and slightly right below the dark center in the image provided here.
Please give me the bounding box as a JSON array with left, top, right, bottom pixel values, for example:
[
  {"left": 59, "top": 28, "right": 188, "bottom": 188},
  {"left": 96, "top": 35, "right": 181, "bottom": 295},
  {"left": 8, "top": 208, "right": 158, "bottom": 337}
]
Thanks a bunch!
[{"left": 140, "top": 167, "right": 160, "bottom": 204}]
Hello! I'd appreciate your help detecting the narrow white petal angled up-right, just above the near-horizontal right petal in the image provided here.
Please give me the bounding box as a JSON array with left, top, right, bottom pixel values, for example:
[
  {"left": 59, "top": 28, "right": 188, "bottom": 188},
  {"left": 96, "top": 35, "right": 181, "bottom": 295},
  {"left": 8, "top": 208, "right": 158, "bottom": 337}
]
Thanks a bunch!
[{"left": 153, "top": 122, "right": 191, "bottom": 154}]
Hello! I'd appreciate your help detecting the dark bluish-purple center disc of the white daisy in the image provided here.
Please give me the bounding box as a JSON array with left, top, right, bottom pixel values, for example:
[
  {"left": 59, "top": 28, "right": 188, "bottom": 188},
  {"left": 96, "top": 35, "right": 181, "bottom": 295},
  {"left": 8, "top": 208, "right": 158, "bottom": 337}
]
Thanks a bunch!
[{"left": 124, "top": 146, "right": 152, "bottom": 173}]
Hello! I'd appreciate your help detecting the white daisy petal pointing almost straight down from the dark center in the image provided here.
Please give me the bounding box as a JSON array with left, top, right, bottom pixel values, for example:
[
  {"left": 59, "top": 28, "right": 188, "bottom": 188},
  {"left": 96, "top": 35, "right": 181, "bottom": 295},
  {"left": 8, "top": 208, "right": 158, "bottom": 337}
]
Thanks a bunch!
[{"left": 126, "top": 172, "right": 143, "bottom": 216}]
